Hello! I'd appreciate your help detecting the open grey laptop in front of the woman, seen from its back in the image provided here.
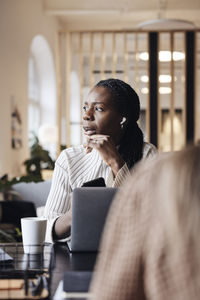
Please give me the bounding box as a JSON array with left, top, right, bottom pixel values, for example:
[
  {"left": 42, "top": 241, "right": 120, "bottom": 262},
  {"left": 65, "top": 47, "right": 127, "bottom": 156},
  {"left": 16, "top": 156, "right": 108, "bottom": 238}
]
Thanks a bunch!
[{"left": 67, "top": 187, "right": 117, "bottom": 252}]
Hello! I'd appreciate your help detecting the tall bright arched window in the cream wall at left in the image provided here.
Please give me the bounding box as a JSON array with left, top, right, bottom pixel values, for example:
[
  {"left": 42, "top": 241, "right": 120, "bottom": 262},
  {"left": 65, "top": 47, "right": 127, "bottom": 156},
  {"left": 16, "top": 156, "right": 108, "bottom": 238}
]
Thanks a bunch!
[{"left": 28, "top": 35, "right": 57, "bottom": 159}]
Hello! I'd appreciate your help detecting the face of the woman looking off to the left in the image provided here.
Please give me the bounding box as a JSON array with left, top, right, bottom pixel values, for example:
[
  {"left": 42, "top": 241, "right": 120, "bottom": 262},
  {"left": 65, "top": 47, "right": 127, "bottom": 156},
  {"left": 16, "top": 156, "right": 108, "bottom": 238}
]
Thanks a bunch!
[{"left": 83, "top": 86, "right": 123, "bottom": 144}]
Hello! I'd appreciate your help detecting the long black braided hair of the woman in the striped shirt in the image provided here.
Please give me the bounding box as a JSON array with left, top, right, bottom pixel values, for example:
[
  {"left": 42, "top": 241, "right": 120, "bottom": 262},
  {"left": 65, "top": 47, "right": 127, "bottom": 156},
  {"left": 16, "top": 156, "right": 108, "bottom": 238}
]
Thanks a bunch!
[{"left": 96, "top": 78, "right": 144, "bottom": 169}]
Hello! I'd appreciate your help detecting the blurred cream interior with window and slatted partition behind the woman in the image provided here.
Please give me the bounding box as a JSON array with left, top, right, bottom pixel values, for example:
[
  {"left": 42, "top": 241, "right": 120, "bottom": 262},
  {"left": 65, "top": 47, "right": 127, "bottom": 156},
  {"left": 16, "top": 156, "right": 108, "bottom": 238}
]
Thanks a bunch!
[{"left": 0, "top": 0, "right": 200, "bottom": 178}]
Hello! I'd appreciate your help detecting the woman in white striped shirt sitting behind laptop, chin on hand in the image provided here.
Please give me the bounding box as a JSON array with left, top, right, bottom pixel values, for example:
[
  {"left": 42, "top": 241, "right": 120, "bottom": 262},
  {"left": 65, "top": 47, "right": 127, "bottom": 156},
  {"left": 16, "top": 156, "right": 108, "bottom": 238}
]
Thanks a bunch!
[{"left": 45, "top": 78, "right": 156, "bottom": 241}]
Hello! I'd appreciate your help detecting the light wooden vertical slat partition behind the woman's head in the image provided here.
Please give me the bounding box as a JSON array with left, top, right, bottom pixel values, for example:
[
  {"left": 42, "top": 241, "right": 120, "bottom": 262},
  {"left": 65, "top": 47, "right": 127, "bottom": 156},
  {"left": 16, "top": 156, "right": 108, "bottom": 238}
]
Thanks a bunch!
[{"left": 56, "top": 30, "right": 200, "bottom": 153}]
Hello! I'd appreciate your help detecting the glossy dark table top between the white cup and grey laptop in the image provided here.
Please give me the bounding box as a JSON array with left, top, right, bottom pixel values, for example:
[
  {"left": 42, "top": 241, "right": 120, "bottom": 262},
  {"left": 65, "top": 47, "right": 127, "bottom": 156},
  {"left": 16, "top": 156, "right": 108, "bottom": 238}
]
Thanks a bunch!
[{"left": 51, "top": 243, "right": 97, "bottom": 299}]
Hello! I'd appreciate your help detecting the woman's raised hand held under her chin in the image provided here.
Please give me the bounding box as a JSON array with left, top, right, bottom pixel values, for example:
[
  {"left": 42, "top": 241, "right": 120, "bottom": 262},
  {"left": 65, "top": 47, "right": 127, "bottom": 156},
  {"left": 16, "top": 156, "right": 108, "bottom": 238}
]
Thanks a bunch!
[{"left": 85, "top": 134, "right": 125, "bottom": 175}]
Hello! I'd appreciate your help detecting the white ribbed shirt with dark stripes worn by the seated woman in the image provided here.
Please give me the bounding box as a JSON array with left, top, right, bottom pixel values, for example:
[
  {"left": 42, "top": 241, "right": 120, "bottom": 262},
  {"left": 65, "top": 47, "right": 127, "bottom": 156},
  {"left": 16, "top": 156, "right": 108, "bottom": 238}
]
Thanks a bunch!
[{"left": 44, "top": 143, "right": 157, "bottom": 242}]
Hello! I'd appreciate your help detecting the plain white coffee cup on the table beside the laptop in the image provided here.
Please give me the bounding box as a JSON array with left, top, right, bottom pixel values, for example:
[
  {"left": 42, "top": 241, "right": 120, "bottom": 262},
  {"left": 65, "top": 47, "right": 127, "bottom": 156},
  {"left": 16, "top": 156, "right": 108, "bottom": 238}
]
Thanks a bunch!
[{"left": 21, "top": 217, "right": 47, "bottom": 254}]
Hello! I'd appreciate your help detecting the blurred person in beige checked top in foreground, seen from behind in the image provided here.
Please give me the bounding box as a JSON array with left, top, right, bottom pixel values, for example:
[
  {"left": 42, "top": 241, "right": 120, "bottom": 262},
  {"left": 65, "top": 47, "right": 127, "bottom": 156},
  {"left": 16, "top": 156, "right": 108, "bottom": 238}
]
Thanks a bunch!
[{"left": 90, "top": 145, "right": 200, "bottom": 300}]
